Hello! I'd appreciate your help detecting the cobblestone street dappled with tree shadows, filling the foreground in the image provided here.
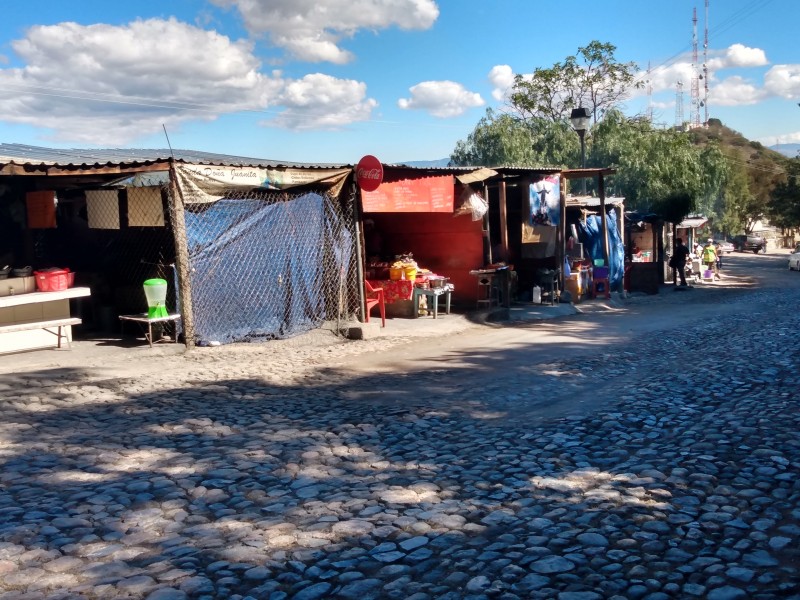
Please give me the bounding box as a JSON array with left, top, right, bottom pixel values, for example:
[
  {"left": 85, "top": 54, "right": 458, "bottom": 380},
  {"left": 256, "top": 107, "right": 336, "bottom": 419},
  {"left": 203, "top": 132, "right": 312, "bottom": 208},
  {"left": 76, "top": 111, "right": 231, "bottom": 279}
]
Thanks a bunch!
[{"left": 0, "top": 251, "right": 800, "bottom": 600}]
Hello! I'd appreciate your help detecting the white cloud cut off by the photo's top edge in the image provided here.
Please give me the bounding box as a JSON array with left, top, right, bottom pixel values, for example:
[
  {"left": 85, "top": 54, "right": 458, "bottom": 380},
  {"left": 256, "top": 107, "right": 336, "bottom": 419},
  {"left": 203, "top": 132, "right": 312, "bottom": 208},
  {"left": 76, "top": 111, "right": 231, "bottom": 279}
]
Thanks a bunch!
[{"left": 212, "top": 0, "right": 439, "bottom": 64}]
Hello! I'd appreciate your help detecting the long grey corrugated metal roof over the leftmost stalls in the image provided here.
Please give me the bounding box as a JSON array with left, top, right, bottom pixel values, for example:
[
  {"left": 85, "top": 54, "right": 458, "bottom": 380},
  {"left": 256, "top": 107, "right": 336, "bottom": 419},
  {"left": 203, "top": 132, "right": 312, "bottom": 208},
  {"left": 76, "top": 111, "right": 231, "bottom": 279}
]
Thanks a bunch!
[{"left": 0, "top": 144, "right": 351, "bottom": 169}]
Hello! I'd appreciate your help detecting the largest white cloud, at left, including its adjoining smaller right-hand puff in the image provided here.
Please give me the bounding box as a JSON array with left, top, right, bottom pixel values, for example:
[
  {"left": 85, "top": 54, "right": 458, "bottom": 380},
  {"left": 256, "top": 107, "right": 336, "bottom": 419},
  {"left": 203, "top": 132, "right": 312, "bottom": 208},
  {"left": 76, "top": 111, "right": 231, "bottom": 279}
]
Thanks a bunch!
[{"left": 0, "top": 19, "right": 374, "bottom": 145}]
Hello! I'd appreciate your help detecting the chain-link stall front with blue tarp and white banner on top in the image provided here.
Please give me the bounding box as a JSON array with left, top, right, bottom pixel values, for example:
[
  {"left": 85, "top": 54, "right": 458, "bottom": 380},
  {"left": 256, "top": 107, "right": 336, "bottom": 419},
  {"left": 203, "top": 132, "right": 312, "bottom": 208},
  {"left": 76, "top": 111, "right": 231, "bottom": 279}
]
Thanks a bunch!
[{"left": 173, "top": 164, "right": 359, "bottom": 343}]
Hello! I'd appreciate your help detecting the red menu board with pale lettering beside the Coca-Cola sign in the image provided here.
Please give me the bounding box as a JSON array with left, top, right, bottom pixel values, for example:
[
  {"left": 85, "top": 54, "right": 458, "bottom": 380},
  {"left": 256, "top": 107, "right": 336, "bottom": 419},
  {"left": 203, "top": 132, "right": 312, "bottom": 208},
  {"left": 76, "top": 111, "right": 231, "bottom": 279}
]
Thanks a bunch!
[{"left": 361, "top": 175, "right": 455, "bottom": 213}]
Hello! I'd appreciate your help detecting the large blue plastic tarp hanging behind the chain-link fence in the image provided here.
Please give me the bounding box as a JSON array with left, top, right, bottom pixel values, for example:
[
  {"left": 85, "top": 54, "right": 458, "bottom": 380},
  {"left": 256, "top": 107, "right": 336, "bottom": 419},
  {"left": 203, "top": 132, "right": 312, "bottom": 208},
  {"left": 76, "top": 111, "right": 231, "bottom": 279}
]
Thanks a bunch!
[{"left": 186, "top": 193, "right": 351, "bottom": 344}]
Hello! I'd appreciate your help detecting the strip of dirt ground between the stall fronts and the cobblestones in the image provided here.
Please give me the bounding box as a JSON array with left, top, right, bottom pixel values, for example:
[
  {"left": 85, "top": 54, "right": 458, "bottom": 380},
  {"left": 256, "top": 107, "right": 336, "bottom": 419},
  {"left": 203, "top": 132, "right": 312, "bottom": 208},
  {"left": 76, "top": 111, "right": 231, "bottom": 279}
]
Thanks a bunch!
[{"left": 0, "top": 246, "right": 800, "bottom": 392}]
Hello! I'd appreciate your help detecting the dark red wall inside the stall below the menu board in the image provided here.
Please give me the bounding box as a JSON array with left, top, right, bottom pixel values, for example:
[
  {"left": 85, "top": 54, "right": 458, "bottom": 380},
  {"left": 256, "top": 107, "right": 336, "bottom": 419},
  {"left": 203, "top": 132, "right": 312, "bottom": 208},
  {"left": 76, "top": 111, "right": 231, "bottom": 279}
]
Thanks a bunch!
[{"left": 364, "top": 213, "right": 484, "bottom": 308}]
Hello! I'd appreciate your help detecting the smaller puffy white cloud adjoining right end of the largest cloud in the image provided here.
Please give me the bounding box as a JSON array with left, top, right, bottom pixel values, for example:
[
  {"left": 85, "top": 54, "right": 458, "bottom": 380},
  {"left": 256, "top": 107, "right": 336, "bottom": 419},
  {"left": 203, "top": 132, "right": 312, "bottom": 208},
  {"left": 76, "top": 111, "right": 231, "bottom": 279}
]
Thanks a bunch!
[{"left": 268, "top": 73, "right": 378, "bottom": 129}]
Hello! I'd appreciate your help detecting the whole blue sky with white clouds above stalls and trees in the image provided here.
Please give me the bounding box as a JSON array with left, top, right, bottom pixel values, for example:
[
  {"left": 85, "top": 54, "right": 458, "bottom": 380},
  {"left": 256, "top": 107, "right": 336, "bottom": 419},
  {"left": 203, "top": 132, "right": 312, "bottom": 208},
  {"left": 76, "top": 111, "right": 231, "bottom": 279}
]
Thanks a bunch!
[{"left": 0, "top": 0, "right": 800, "bottom": 163}]
